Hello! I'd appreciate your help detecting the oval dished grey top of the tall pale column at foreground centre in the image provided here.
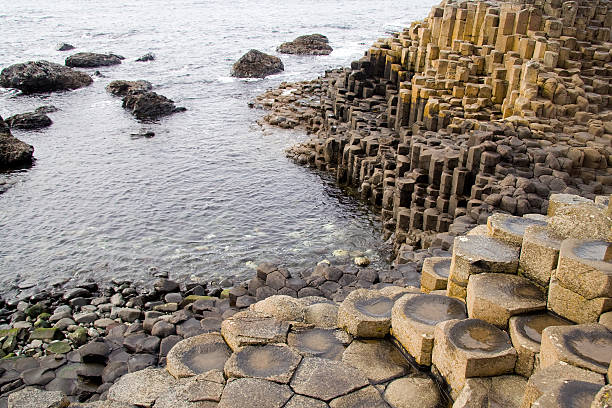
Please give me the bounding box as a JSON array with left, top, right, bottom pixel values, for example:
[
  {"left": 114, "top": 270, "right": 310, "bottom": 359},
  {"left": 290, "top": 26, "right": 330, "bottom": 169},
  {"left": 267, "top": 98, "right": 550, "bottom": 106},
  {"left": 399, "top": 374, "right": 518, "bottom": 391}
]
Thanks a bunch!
[{"left": 404, "top": 295, "right": 466, "bottom": 326}]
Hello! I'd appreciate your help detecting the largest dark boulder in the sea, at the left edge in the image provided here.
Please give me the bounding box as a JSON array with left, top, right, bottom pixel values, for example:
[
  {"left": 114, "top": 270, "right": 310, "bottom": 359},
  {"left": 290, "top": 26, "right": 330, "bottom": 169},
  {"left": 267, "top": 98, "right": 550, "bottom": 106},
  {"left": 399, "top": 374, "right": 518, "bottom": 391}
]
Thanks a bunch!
[{"left": 0, "top": 61, "right": 93, "bottom": 94}]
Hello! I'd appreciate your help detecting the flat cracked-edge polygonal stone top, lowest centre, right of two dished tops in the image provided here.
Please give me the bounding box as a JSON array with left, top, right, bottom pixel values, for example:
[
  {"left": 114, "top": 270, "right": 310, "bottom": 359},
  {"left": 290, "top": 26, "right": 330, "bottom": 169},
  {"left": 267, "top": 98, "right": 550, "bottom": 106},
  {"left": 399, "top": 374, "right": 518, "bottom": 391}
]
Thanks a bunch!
[{"left": 291, "top": 357, "right": 369, "bottom": 401}]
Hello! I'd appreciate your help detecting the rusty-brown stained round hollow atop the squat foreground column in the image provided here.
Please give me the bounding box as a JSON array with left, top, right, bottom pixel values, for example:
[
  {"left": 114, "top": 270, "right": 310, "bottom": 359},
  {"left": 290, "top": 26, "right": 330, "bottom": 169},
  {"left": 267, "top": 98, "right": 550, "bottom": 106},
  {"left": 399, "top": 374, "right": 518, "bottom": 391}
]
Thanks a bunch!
[{"left": 449, "top": 319, "right": 512, "bottom": 354}]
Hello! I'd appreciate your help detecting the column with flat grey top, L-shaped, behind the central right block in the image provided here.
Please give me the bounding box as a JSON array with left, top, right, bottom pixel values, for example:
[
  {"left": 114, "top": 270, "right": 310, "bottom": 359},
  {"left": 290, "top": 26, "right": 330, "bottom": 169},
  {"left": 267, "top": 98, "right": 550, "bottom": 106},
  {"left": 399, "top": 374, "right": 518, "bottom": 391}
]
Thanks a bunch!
[{"left": 447, "top": 235, "right": 519, "bottom": 299}]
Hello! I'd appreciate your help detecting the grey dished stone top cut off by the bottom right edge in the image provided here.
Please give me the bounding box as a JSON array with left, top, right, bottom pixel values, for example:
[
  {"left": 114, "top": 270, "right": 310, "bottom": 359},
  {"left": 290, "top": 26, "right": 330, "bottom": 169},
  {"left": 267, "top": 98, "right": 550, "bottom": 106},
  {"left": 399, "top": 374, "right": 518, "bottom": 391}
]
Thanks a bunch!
[{"left": 531, "top": 381, "right": 601, "bottom": 408}]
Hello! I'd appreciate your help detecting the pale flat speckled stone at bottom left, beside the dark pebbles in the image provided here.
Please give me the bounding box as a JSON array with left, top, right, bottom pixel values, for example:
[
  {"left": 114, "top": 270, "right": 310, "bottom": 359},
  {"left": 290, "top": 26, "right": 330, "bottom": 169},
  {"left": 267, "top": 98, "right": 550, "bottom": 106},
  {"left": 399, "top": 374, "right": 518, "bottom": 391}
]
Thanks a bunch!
[{"left": 107, "top": 368, "right": 176, "bottom": 407}]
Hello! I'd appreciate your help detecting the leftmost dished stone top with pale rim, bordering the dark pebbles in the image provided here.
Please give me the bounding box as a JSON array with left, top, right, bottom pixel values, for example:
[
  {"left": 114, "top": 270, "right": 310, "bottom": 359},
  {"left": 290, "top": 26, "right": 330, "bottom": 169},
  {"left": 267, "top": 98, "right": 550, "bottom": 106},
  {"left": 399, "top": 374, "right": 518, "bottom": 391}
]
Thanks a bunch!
[{"left": 166, "top": 333, "right": 231, "bottom": 378}]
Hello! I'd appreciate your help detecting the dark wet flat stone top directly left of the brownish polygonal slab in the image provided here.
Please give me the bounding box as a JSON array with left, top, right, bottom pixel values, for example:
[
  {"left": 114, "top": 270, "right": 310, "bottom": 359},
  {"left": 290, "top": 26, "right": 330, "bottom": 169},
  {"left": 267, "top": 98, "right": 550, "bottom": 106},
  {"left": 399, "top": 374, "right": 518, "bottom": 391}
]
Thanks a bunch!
[{"left": 287, "top": 328, "right": 352, "bottom": 360}]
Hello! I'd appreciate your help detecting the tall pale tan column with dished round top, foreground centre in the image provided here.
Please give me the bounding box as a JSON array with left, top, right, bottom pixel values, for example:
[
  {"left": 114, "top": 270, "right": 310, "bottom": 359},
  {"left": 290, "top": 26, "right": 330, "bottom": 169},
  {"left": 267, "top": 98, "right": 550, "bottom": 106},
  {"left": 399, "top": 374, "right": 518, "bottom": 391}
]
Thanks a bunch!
[{"left": 391, "top": 294, "right": 467, "bottom": 365}]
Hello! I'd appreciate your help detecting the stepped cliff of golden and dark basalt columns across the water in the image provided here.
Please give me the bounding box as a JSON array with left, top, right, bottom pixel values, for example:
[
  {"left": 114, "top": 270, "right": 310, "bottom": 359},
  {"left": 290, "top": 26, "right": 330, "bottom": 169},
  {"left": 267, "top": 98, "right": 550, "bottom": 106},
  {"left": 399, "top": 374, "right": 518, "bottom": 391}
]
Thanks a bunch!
[{"left": 258, "top": 1, "right": 612, "bottom": 255}]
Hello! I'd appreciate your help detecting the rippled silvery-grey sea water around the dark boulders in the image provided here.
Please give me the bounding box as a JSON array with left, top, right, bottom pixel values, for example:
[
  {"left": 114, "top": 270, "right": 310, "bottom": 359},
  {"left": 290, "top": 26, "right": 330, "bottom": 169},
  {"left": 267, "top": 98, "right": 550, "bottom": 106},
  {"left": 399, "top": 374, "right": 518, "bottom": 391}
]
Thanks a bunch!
[{"left": 0, "top": 0, "right": 436, "bottom": 293}]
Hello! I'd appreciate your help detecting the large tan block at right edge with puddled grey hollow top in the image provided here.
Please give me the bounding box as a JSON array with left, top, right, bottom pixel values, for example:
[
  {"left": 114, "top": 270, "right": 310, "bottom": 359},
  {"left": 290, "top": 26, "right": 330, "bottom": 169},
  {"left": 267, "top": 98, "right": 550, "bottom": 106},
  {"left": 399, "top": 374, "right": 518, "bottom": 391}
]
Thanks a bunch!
[{"left": 556, "top": 239, "right": 612, "bottom": 299}]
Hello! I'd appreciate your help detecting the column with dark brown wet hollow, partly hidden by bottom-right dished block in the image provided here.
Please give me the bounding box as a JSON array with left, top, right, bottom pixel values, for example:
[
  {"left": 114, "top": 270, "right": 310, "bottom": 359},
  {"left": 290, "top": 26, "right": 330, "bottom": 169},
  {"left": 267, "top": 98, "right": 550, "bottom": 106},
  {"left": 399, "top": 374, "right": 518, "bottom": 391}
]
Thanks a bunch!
[{"left": 509, "top": 312, "right": 571, "bottom": 377}]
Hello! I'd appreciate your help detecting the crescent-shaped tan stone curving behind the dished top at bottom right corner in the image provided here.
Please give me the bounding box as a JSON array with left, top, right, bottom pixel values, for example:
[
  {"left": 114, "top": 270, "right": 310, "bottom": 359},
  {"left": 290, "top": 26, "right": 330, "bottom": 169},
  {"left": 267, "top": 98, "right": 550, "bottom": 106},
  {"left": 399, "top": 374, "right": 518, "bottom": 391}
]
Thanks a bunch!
[{"left": 521, "top": 361, "right": 605, "bottom": 408}]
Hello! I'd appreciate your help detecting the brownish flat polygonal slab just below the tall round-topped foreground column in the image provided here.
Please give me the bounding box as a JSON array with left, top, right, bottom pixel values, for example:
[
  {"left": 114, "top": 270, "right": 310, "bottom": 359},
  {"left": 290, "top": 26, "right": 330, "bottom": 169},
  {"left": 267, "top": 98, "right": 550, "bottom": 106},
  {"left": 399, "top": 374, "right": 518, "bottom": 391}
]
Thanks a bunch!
[{"left": 342, "top": 340, "right": 410, "bottom": 384}]
